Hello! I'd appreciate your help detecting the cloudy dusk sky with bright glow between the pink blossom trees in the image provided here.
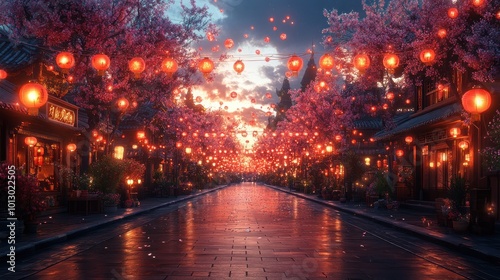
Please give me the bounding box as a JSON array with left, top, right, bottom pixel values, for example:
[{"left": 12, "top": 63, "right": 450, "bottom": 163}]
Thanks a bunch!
[{"left": 172, "top": 0, "right": 361, "bottom": 147}]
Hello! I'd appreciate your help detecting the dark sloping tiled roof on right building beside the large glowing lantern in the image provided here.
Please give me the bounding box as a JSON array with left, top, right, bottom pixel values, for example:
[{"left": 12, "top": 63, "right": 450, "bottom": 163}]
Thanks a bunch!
[{"left": 374, "top": 103, "right": 462, "bottom": 140}]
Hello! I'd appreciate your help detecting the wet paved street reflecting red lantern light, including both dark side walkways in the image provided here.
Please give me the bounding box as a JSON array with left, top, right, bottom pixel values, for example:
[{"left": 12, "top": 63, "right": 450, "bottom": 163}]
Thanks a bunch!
[{"left": 0, "top": 183, "right": 500, "bottom": 279}]
